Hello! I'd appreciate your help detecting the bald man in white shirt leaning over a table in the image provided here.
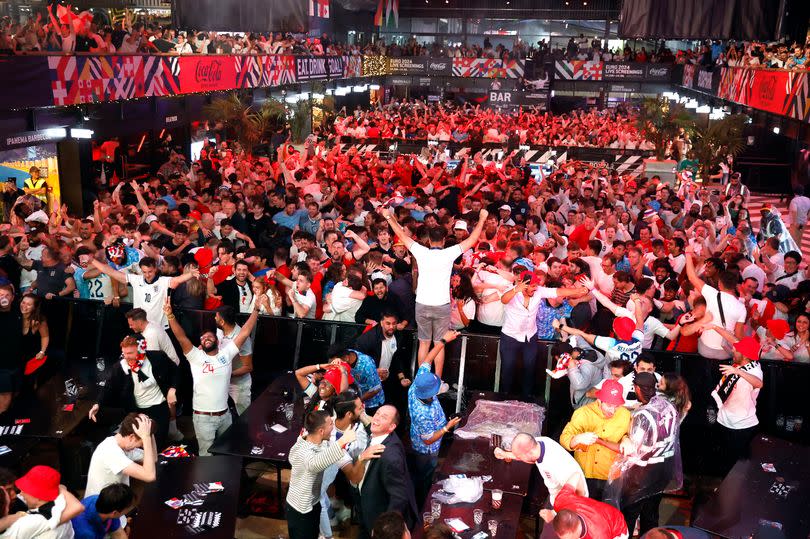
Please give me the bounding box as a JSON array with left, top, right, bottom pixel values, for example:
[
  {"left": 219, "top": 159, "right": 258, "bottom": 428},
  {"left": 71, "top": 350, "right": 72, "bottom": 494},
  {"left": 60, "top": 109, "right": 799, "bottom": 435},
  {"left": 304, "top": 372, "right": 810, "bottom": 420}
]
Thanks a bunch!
[{"left": 495, "top": 432, "right": 588, "bottom": 506}]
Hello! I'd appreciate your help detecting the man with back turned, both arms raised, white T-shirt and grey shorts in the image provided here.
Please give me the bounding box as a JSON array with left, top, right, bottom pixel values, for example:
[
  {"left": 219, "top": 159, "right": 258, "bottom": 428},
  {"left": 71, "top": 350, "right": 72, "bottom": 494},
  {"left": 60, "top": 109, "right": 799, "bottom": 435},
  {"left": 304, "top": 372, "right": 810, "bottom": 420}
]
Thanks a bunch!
[{"left": 382, "top": 208, "right": 488, "bottom": 391}]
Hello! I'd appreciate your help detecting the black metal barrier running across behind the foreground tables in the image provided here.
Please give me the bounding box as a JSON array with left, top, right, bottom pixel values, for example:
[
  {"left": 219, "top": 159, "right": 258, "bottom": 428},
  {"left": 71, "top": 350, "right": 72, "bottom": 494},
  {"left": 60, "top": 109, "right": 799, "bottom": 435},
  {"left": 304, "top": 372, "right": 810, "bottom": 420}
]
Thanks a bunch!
[{"left": 45, "top": 299, "right": 810, "bottom": 471}]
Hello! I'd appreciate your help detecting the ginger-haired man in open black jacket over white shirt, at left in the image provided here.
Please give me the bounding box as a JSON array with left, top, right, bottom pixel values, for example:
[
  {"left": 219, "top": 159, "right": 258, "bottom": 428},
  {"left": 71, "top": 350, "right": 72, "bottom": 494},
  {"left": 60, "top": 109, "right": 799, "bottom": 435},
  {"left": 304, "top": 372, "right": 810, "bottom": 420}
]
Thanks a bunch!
[{"left": 89, "top": 335, "right": 179, "bottom": 448}]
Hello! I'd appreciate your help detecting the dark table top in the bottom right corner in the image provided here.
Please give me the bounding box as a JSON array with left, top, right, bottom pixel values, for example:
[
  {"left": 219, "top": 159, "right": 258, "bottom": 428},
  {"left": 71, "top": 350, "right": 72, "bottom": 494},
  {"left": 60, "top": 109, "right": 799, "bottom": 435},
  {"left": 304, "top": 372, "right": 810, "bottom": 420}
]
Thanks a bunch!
[{"left": 693, "top": 435, "right": 810, "bottom": 539}]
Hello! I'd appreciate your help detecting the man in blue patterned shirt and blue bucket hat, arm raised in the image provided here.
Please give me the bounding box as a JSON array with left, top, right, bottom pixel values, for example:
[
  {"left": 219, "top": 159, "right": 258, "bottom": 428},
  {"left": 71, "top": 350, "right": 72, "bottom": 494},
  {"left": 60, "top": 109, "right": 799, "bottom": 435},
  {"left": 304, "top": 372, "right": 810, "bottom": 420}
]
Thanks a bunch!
[{"left": 408, "top": 331, "right": 461, "bottom": 507}]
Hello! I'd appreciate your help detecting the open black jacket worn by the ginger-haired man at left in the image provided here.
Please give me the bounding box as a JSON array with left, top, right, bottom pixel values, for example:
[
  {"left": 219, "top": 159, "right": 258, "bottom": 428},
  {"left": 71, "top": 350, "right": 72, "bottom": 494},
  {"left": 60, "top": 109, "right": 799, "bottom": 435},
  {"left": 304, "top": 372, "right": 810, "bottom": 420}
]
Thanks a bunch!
[{"left": 98, "top": 350, "right": 179, "bottom": 412}]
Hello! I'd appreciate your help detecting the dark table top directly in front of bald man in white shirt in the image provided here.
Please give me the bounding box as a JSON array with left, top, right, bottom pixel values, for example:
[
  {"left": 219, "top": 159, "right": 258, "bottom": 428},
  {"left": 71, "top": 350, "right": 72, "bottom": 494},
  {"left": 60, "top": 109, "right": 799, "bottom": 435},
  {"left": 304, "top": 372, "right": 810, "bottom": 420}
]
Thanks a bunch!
[{"left": 439, "top": 438, "right": 532, "bottom": 496}]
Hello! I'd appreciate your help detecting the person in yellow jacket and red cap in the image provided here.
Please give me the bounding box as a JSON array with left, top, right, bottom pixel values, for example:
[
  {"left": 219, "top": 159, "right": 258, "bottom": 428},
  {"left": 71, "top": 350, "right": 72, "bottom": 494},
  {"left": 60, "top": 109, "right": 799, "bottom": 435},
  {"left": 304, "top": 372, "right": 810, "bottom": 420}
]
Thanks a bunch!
[{"left": 560, "top": 380, "right": 630, "bottom": 500}]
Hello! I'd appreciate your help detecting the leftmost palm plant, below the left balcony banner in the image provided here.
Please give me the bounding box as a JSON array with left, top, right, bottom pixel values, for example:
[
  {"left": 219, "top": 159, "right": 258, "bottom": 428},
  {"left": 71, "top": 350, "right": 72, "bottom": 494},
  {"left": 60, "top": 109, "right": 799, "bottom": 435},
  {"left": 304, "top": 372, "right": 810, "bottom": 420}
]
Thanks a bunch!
[{"left": 203, "top": 92, "right": 286, "bottom": 155}]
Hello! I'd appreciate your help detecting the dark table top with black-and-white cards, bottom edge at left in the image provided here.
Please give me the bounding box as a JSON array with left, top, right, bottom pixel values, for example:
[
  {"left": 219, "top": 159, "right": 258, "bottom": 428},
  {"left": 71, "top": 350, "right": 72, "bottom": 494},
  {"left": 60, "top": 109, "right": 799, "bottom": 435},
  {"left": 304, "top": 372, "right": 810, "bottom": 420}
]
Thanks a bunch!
[{"left": 130, "top": 456, "right": 242, "bottom": 539}]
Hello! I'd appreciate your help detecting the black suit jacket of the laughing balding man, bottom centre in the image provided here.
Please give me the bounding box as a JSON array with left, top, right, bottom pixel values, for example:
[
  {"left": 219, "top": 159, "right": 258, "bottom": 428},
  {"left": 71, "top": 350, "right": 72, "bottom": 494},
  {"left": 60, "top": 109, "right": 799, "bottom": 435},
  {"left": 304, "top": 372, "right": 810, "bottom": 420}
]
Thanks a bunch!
[{"left": 360, "top": 432, "right": 418, "bottom": 536}]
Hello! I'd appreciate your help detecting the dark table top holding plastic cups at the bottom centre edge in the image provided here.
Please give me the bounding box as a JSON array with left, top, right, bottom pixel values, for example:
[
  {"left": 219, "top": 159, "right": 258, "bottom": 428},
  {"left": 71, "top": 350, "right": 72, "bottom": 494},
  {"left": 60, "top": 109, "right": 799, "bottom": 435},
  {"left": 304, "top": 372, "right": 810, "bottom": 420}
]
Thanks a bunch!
[{"left": 412, "top": 485, "right": 523, "bottom": 539}]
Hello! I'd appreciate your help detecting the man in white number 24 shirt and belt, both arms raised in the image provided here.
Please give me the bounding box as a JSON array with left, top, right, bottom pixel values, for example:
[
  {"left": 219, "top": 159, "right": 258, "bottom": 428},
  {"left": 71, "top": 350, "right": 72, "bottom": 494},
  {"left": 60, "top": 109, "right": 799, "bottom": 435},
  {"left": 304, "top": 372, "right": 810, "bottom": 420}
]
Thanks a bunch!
[{"left": 163, "top": 296, "right": 260, "bottom": 456}]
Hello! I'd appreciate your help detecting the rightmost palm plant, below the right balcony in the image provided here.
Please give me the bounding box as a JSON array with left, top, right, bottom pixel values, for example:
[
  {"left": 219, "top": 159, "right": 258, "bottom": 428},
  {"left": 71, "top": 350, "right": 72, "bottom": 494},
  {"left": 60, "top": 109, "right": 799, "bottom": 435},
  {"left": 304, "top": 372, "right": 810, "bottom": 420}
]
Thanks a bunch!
[{"left": 692, "top": 114, "right": 748, "bottom": 181}]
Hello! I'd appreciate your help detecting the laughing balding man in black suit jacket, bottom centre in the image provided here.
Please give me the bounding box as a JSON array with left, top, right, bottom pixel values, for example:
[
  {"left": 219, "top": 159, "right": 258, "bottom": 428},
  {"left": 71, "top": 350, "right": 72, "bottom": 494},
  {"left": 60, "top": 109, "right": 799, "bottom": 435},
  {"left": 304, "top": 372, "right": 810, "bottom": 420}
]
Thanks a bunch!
[{"left": 358, "top": 405, "right": 418, "bottom": 539}]
